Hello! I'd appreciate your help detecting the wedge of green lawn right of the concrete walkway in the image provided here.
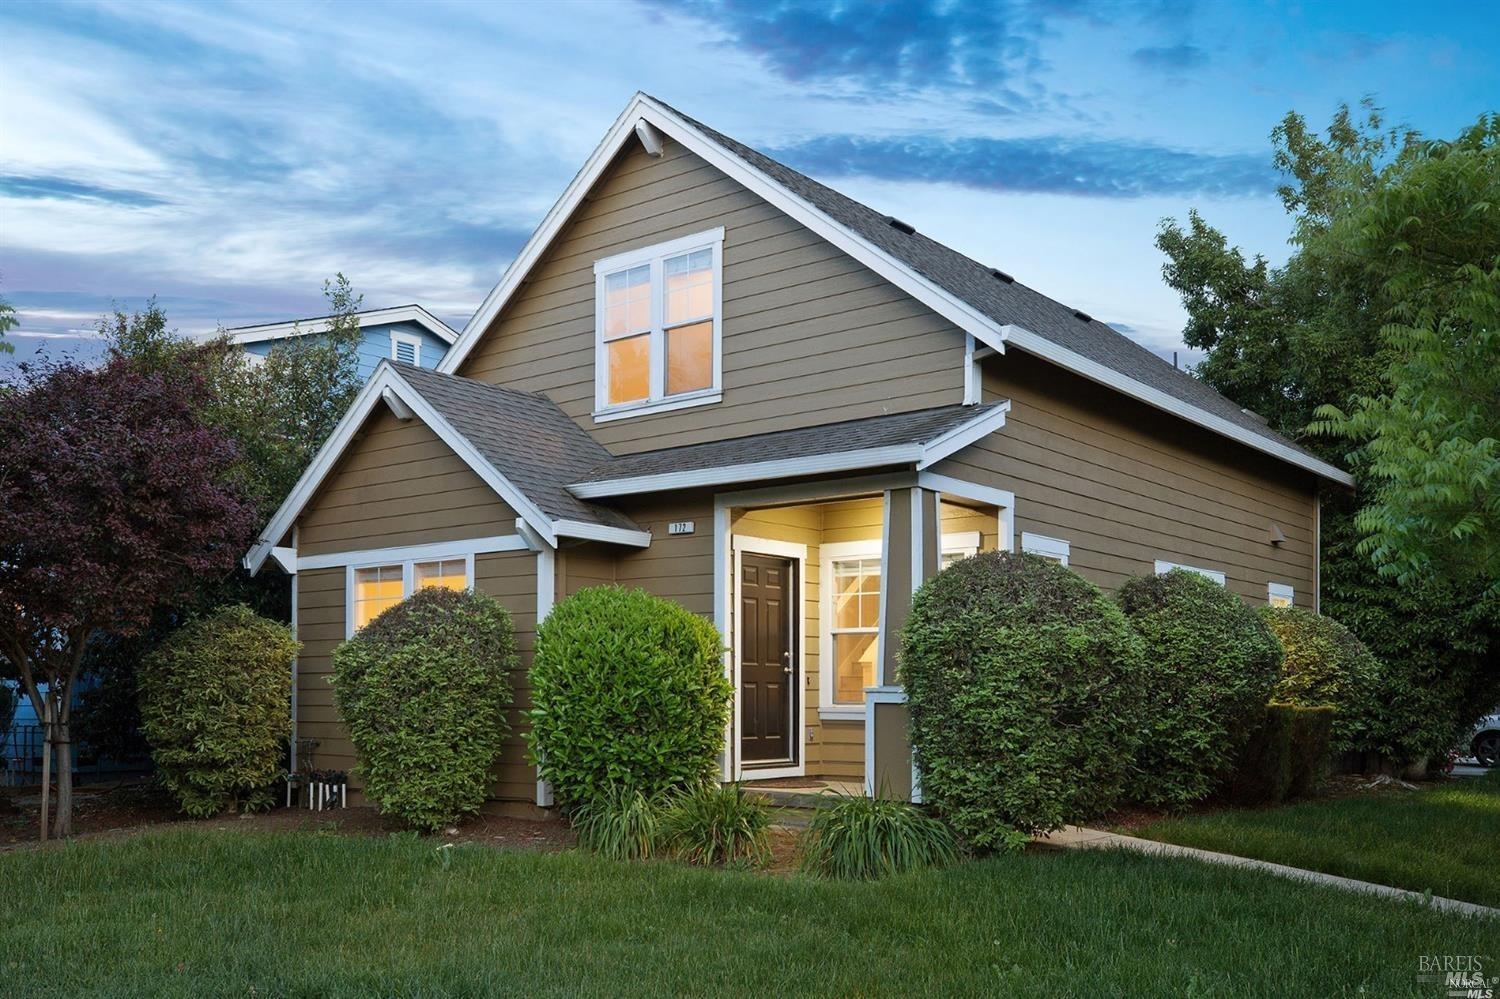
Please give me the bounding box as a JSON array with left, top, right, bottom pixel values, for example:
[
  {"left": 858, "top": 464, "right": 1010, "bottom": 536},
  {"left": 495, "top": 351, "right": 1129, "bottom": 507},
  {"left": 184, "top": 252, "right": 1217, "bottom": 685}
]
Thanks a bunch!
[{"left": 1136, "top": 771, "right": 1500, "bottom": 906}]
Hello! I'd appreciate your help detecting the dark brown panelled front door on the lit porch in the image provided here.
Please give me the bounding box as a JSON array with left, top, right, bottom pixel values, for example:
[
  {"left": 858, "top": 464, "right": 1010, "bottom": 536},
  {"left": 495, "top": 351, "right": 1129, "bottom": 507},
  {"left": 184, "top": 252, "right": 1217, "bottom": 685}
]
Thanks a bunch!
[{"left": 740, "top": 554, "right": 798, "bottom": 767}]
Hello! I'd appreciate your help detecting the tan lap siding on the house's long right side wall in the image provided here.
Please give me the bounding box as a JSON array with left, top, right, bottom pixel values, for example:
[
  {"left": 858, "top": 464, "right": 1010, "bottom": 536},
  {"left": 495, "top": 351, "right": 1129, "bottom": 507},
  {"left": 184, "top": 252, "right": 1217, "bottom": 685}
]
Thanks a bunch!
[{"left": 935, "top": 353, "right": 1316, "bottom": 608}]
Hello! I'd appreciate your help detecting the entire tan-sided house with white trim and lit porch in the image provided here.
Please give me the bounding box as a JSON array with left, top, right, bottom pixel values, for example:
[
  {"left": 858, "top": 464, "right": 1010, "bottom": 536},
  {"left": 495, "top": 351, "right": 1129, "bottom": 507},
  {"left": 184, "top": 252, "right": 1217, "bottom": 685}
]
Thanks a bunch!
[{"left": 246, "top": 95, "right": 1352, "bottom": 804}]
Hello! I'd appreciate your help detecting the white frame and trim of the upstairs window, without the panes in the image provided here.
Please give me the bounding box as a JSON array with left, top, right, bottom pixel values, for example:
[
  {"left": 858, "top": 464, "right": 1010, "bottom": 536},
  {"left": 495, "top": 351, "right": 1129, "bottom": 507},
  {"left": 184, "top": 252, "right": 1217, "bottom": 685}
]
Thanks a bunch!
[{"left": 594, "top": 227, "right": 725, "bottom": 423}]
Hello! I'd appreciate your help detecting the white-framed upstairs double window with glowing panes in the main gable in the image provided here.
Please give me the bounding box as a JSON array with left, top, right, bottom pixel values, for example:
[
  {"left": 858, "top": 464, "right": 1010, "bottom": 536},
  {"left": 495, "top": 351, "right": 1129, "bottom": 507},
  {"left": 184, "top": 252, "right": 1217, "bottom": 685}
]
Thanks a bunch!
[{"left": 594, "top": 228, "right": 725, "bottom": 422}]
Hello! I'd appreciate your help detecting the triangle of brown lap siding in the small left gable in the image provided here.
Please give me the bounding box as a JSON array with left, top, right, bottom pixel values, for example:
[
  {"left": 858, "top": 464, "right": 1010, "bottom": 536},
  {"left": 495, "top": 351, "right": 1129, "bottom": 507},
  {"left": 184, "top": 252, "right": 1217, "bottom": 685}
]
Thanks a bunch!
[{"left": 297, "top": 410, "right": 516, "bottom": 555}]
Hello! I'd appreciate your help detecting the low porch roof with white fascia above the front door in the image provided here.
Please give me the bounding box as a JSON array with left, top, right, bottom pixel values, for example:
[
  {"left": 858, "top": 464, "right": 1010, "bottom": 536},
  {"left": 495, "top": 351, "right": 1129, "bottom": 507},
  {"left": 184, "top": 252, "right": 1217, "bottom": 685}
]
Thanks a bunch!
[{"left": 570, "top": 402, "right": 1011, "bottom": 498}]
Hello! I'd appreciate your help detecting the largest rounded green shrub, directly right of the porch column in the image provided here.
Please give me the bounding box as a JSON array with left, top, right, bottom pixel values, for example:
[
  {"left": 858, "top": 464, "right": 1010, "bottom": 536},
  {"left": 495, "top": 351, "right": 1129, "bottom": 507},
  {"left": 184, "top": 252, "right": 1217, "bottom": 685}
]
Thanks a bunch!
[{"left": 902, "top": 552, "right": 1143, "bottom": 849}]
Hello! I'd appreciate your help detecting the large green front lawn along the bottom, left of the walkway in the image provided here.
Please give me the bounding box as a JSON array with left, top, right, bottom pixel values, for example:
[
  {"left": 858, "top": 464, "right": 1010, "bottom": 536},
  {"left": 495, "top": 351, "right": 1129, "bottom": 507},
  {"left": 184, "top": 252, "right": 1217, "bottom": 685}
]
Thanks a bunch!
[{"left": 0, "top": 830, "right": 1500, "bottom": 996}]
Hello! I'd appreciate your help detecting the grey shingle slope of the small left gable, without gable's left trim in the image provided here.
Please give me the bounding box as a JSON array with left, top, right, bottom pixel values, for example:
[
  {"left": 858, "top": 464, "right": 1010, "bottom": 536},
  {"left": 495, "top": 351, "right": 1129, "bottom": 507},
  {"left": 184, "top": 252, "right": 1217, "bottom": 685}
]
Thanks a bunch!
[{"left": 393, "top": 362, "right": 639, "bottom": 530}]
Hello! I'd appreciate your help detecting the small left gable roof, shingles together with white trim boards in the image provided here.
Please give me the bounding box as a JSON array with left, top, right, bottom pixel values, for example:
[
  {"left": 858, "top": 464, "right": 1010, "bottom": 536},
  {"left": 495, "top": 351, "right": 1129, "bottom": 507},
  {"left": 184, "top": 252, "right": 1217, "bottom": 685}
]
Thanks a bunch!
[{"left": 245, "top": 359, "right": 651, "bottom": 575}]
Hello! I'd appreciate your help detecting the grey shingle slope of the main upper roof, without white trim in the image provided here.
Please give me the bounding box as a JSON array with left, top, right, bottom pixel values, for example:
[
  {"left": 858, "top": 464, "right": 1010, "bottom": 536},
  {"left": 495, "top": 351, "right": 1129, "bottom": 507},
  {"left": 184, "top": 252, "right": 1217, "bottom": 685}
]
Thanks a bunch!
[{"left": 653, "top": 98, "right": 1316, "bottom": 468}]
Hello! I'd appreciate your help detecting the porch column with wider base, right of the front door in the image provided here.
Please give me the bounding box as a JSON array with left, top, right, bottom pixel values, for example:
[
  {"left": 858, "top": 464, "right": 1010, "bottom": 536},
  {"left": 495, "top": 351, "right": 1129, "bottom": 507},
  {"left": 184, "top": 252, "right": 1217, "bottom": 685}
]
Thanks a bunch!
[{"left": 864, "top": 486, "right": 942, "bottom": 801}]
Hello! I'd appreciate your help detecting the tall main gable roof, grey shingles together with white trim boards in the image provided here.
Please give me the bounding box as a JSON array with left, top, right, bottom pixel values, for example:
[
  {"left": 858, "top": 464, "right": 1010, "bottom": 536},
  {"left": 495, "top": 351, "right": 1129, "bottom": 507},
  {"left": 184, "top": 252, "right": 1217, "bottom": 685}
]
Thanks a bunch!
[{"left": 438, "top": 93, "right": 1353, "bottom": 486}]
